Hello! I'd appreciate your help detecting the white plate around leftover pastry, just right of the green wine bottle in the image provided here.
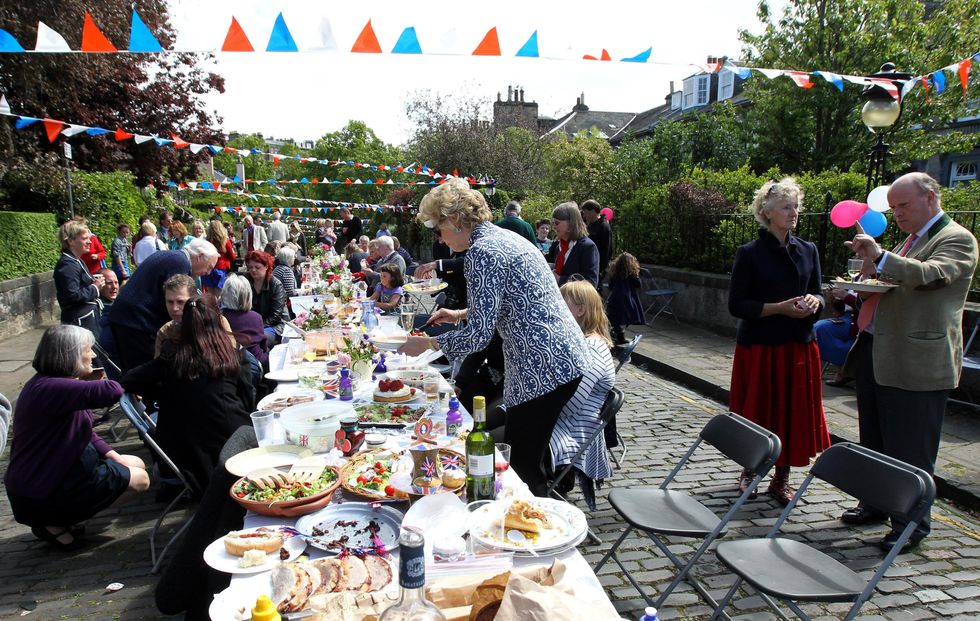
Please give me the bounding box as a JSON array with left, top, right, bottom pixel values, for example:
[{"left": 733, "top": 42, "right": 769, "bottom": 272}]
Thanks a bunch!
[{"left": 470, "top": 498, "right": 588, "bottom": 554}]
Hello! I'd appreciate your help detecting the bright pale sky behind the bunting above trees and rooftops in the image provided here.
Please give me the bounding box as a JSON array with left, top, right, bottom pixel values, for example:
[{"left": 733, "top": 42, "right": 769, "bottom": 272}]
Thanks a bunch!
[{"left": 170, "top": 0, "right": 783, "bottom": 144}]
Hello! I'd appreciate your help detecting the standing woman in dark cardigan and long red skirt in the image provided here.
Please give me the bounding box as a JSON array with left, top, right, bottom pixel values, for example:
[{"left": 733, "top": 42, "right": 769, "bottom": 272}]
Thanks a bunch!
[{"left": 728, "top": 178, "right": 830, "bottom": 505}]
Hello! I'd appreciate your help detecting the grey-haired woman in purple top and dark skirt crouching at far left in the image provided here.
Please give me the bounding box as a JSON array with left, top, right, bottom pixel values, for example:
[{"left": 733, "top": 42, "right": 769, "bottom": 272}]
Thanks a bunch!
[{"left": 4, "top": 325, "right": 150, "bottom": 549}]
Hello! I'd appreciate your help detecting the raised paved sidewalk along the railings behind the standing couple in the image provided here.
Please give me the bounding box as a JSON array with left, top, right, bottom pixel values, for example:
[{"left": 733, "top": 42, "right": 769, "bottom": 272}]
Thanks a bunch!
[{"left": 627, "top": 317, "right": 980, "bottom": 509}]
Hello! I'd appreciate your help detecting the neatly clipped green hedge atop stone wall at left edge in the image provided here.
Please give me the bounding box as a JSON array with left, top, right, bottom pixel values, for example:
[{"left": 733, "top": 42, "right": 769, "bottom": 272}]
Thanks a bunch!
[{"left": 0, "top": 211, "right": 60, "bottom": 280}]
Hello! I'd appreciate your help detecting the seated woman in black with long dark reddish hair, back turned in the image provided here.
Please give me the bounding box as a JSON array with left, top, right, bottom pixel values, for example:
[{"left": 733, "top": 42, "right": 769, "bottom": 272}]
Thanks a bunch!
[{"left": 122, "top": 297, "right": 255, "bottom": 492}]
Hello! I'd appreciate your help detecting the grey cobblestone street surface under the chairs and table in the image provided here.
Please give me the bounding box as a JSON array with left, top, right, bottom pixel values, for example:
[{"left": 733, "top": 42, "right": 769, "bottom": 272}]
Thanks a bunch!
[{"left": 0, "top": 366, "right": 980, "bottom": 621}]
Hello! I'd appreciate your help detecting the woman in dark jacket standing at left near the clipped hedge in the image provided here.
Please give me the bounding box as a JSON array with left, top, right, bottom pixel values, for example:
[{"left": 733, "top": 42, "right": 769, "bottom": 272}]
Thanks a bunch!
[{"left": 54, "top": 220, "right": 103, "bottom": 337}]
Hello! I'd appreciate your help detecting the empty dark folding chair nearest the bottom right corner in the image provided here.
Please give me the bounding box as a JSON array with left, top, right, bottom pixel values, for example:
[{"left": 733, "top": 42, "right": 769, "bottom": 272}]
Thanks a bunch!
[{"left": 712, "top": 442, "right": 936, "bottom": 621}]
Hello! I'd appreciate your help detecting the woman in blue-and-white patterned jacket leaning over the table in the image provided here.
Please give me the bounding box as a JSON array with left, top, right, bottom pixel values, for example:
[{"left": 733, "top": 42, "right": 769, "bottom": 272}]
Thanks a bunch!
[{"left": 402, "top": 179, "right": 589, "bottom": 495}]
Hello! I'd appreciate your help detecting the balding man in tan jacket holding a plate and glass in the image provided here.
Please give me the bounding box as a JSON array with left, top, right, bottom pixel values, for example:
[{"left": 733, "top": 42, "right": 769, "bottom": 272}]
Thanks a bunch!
[{"left": 841, "top": 173, "right": 977, "bottom": 549}]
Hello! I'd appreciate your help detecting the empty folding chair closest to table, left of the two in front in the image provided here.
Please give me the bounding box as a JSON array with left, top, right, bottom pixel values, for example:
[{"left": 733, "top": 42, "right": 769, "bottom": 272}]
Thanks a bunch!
[{"left": 595, "top": 412, "right": 781, "bottom": 619}]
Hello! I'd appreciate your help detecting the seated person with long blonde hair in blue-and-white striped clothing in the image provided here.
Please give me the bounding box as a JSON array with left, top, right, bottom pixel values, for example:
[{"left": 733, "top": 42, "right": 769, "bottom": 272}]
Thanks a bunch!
[{"left": 549, "top": 280, "right": 616, "bottom": 510}]
